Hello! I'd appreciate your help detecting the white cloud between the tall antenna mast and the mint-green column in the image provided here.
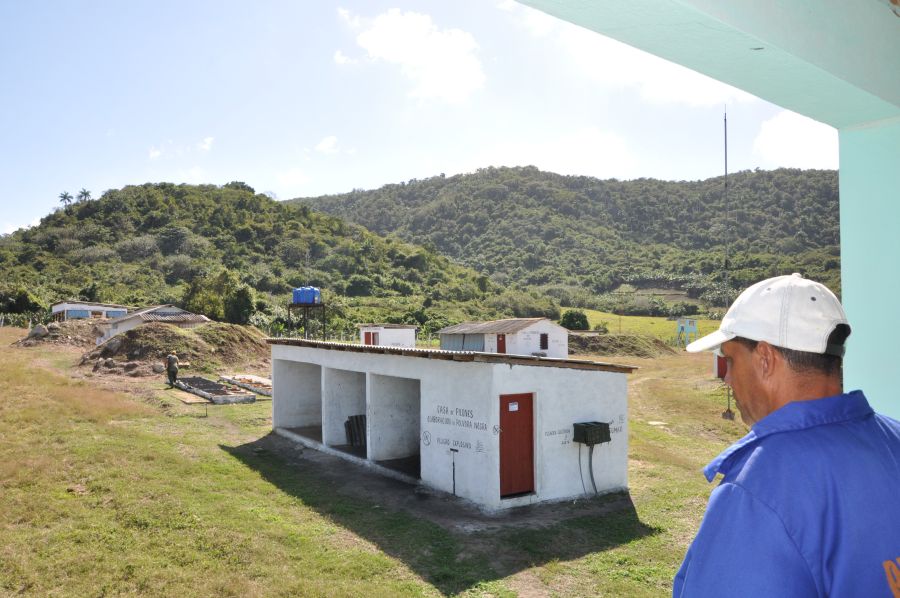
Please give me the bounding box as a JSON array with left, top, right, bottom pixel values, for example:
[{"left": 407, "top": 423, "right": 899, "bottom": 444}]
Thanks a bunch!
[{"left": 753, "top": 110, "right": 839, "bottom": 169}]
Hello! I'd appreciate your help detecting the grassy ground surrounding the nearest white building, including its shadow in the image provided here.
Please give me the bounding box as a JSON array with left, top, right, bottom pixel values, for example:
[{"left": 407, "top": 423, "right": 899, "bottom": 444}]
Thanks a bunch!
[{"left": 0, "top": 328, "right": 745, "bottom": 597}]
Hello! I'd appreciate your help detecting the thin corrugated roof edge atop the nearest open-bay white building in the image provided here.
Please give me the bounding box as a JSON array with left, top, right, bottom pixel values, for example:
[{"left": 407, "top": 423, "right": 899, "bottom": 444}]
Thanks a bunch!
[{"left": 266, "top": 340, "right": 638, "bottom": 374}]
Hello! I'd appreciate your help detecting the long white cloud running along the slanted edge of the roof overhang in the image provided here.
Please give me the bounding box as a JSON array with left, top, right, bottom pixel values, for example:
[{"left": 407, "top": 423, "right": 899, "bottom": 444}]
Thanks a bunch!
[{"left": 512, "top": 5, "right": 757, "bottom": 107}]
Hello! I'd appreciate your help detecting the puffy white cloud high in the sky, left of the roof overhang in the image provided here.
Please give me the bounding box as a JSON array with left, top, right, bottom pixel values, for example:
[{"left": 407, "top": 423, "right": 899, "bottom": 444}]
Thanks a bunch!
[{"left": 347, "top": 8, "right": 485, "bottom": 103}]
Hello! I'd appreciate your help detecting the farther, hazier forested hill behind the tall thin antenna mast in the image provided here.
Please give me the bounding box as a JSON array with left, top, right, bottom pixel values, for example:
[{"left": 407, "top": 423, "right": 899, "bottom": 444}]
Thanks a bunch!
[{"left": 293, "top": 167, "right": 840, "bottom": 307}]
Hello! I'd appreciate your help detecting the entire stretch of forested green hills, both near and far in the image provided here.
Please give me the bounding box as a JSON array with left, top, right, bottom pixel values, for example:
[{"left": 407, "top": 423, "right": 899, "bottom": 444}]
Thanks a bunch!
[{"left": 0, "top": 167, "right": 840, "bottom": 334}]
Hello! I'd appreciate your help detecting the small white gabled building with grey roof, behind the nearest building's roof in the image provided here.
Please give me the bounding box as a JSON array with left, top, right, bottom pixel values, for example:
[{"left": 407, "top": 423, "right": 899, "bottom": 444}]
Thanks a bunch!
[{"left": 438, "top": 318, "right": 569, "bottom": 358}]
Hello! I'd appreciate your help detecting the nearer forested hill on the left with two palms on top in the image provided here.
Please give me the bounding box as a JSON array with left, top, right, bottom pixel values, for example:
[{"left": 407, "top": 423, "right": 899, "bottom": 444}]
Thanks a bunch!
[{"left": 0, "top": 183, "right": 558, "bottom": 332}]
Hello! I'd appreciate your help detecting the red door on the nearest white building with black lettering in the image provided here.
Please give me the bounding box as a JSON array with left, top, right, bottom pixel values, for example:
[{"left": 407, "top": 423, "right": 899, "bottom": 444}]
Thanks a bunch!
[{"left": 500, "top": 394, "right": 534, "bottom": 496}]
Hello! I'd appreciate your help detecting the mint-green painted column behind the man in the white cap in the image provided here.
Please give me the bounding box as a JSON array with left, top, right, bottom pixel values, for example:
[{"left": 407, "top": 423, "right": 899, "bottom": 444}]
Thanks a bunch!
[{"left": 840, "top": 119, "right": 900, "bottom": 419}]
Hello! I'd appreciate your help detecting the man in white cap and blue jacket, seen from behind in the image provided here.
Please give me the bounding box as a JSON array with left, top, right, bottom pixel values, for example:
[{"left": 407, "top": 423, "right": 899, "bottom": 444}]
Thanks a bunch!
[{"left": 673, "top": 274, "right": 900, "bottom": 598}]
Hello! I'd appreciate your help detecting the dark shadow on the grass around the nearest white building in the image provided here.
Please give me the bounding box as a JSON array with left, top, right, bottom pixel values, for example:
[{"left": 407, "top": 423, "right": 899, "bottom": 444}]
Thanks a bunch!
[{"left": 220, "top": 433, "right": 660, "bottom": 594}]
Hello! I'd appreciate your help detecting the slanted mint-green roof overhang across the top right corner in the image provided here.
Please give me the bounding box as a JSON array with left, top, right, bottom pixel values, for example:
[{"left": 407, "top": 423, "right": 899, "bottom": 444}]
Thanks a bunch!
[{"left": 521, "top": 0, "right": 900, "bottom": 128}]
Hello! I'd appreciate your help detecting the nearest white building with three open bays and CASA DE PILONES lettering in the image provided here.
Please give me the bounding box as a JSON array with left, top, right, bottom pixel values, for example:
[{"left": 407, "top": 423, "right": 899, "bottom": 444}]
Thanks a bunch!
[{"left": 268, "top": 338, "right": 634, "bottom": 510}]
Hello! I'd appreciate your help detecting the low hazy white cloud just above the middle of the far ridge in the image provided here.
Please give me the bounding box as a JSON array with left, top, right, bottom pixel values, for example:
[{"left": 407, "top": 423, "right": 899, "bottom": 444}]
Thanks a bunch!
[{"left": 469, "top": 127, "right": 639, "bottom": 178}]
